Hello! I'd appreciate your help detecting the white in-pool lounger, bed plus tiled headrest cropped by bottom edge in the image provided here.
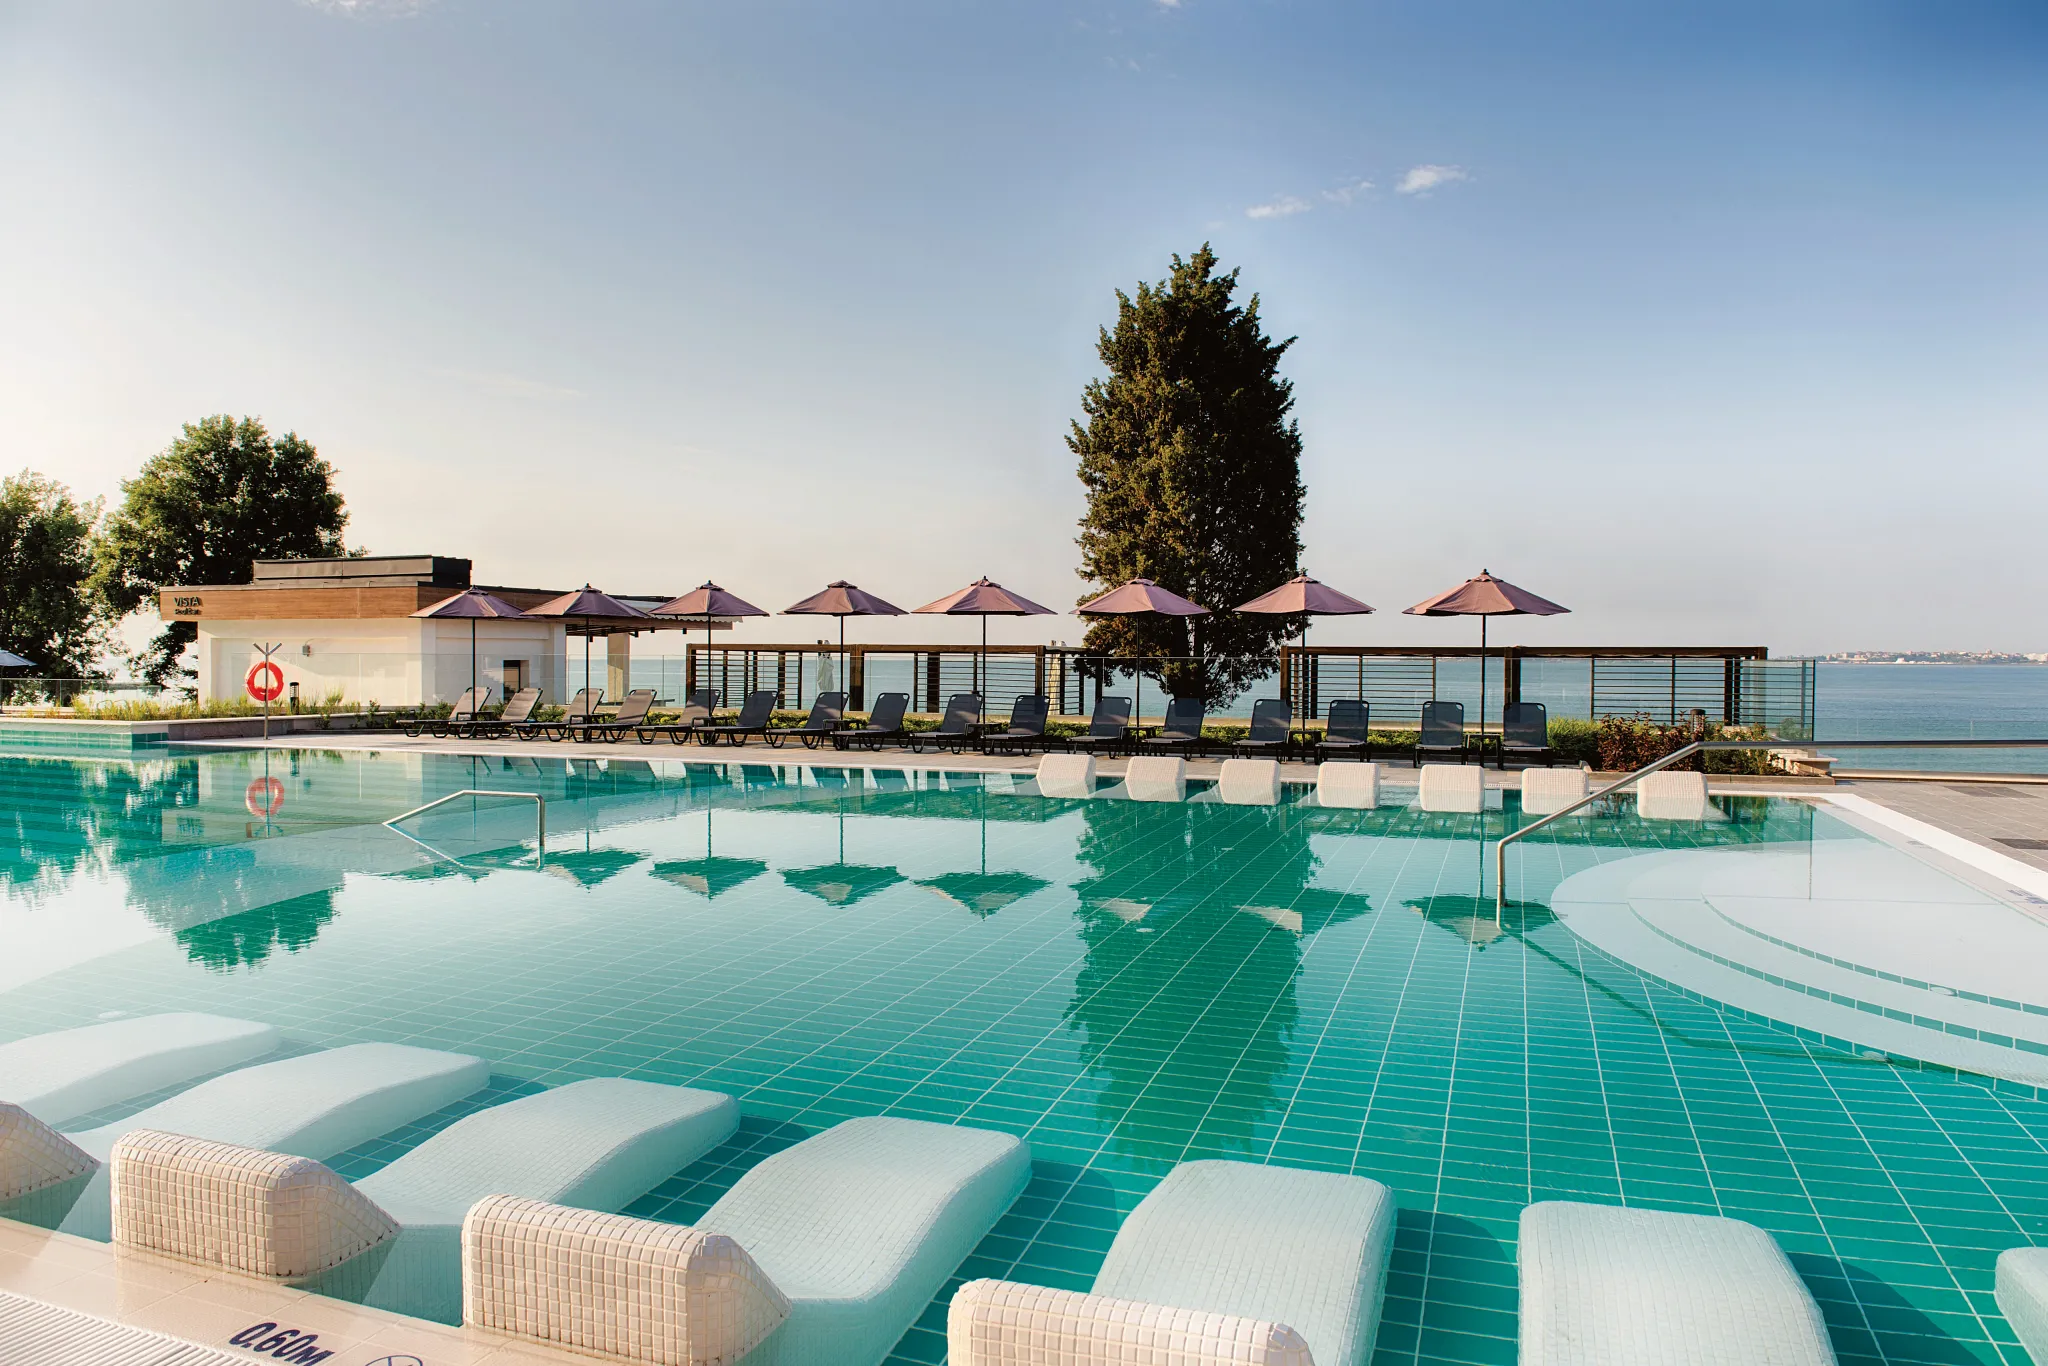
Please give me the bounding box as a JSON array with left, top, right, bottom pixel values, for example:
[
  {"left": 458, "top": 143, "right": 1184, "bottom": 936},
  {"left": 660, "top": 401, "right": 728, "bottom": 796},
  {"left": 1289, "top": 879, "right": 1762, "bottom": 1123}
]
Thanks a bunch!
[{"left": 946, "top": 1161, "right": 1395, "bottom": 1366}]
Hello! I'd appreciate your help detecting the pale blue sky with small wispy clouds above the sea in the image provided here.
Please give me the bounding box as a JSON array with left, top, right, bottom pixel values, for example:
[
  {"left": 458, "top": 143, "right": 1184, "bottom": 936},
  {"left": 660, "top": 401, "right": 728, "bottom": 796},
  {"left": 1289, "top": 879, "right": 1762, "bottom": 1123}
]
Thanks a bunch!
[{"left": 0, "top": 0, "right": 2048, "bottom": 653}]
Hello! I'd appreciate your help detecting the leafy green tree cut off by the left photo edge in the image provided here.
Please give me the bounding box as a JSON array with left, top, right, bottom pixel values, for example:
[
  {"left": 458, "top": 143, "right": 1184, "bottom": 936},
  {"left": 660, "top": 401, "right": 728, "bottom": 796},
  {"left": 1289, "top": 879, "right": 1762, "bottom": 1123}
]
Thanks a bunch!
[{"left": 0, "top": 471, "right": 109, "bottom": 678}]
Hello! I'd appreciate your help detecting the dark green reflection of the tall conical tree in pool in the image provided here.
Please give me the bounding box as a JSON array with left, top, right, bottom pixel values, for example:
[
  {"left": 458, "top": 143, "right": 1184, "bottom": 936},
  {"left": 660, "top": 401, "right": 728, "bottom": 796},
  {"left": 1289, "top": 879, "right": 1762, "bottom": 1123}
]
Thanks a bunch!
[{"left": 1065, "top": 801, "right": 1370, "bottom": 1169}]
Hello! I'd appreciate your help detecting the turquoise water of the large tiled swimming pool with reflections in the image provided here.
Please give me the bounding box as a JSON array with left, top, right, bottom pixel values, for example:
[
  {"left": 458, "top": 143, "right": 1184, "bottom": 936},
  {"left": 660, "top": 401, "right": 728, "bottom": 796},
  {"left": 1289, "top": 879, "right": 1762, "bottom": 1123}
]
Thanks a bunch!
[{"left": 0, "top": 752, "right": 2048, "bottom": 1362}]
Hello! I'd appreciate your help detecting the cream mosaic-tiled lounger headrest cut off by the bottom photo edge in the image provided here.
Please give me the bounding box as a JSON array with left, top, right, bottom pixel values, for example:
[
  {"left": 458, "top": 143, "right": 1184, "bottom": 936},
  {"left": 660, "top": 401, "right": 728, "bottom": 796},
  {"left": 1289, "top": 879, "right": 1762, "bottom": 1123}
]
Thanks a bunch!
[{"left": 946, "top": 1280, "right": 1315, "bottom": 1366}]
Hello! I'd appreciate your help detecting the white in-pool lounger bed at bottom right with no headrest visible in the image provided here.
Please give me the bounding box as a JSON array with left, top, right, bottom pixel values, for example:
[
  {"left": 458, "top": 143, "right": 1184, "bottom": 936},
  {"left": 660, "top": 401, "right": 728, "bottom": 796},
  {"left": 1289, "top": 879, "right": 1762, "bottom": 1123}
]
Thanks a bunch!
[{"left": 1516, "top": 1200, "right": 1835, "bottom": 1366}]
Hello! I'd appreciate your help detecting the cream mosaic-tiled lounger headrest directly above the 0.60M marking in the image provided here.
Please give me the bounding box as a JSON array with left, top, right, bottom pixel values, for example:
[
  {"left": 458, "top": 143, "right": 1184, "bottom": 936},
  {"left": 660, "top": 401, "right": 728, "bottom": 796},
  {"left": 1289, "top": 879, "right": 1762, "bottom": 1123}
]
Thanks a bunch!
[{"left": 109, "top": 1128, "right": 397, "bottom": 1278}]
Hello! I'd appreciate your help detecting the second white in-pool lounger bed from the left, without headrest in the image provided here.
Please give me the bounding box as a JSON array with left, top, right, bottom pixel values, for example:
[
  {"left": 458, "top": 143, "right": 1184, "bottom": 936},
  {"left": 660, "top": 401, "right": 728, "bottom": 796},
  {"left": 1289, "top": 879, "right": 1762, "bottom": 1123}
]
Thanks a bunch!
[{"left": 63, "top": 1044, "right": 492, "bottom": 1239}]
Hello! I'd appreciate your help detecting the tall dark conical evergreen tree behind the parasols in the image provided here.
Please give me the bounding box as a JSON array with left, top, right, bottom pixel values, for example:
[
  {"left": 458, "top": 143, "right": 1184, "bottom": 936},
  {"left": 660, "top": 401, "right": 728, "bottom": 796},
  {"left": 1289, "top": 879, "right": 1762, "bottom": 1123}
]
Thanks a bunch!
[{"left": 1067, "top": 242, "right": 1303, "bottom": 705}]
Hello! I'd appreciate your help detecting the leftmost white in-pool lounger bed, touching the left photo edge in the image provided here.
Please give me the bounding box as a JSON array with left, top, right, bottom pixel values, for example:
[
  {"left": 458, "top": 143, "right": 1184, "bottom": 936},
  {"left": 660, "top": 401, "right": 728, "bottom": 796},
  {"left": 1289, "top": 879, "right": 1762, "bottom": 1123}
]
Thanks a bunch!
[{"left": 0, "top": 1012, "right": 279, "bottom": 1124}]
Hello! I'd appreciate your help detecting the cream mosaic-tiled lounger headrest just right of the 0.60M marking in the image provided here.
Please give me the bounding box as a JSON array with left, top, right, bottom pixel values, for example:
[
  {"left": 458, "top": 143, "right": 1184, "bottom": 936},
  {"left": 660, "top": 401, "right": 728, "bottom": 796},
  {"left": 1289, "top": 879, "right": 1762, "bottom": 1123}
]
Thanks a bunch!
[{"left": 463, "top": 1196, "right": 788, "bottom": 1366}]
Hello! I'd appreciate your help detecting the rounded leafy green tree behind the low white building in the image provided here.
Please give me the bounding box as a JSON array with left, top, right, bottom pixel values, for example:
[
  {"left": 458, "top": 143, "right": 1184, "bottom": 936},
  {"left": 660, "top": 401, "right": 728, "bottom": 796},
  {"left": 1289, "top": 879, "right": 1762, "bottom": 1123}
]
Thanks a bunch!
[{"left": 94, "top": 414, "right": 348, "bottom": 682}]
